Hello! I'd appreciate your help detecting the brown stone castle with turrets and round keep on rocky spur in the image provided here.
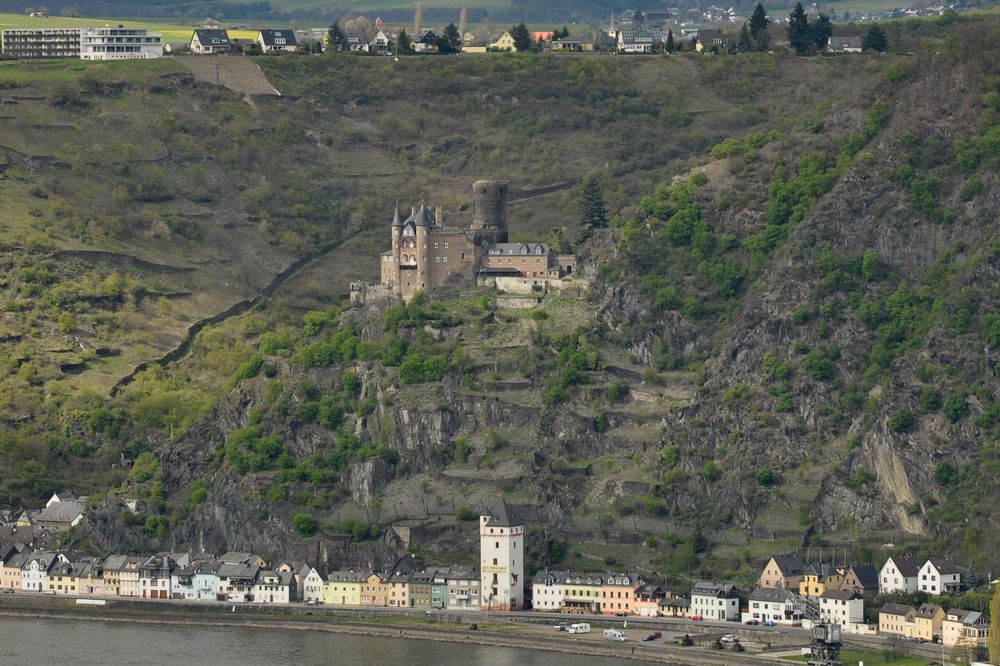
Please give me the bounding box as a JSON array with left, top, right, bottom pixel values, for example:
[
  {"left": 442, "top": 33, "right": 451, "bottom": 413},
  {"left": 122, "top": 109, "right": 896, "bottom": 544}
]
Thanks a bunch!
[{"left": 351, "top": 180, "right": 576, "bottom": 303}]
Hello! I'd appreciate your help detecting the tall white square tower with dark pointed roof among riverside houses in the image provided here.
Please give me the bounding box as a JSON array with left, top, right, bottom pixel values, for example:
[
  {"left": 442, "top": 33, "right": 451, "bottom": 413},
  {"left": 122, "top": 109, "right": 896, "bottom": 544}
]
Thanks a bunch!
[{"left": 477, "top": 498, "right": 524, "bottom": 611}]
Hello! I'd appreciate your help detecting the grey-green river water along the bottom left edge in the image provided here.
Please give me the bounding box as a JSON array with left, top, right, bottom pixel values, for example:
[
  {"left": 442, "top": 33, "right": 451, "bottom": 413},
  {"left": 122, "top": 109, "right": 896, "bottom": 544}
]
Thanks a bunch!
[{"left": 0, "top": 617, "right": 634, "bottom": 666}]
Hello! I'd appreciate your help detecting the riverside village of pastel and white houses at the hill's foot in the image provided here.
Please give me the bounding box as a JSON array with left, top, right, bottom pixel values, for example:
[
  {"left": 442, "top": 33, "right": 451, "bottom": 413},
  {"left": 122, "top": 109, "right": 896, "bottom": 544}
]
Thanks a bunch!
[{"left": 0, "top": 493, "right": 996, "bottom": 654}]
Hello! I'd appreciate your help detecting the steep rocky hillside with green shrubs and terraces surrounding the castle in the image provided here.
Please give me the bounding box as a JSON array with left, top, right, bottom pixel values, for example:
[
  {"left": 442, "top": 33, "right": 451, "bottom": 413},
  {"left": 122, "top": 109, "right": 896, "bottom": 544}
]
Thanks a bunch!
[{"left": 0, "top": 24, "right": 1000, "bottom": 578}]
